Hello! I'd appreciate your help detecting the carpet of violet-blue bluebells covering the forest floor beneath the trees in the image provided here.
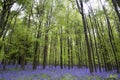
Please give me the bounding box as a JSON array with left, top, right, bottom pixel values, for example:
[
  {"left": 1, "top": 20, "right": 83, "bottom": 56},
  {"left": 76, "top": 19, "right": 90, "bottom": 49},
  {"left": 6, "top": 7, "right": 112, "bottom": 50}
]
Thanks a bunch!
[{"left": 0, "top": 65, "right": 120, "bottom": 80}]
